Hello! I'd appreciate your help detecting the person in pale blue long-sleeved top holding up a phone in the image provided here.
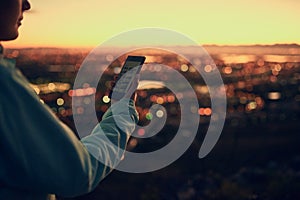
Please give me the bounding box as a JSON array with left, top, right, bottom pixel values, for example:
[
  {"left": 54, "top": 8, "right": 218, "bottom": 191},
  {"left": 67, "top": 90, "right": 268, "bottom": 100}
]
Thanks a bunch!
[{"left": 0, "top": 0, "right": 138, "bottom": 200}]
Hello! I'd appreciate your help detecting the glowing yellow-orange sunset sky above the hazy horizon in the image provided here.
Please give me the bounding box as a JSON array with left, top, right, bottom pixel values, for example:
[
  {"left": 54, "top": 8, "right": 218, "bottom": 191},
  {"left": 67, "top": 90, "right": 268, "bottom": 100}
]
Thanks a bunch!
[{"left": 4, "top": 0, "right": 300, "bottom": 47}]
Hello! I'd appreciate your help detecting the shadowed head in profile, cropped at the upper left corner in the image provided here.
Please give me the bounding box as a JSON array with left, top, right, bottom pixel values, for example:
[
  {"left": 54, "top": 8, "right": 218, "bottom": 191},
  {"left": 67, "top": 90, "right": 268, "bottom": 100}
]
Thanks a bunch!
[{"left": 0, "top": 0, "right": 30, "bottom": 41}]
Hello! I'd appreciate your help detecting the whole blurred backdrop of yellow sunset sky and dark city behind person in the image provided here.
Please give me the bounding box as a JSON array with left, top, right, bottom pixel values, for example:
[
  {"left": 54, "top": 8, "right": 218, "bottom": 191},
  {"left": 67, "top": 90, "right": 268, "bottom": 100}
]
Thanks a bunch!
[{"left": 3, "top": 0, "right": 300, "bottom": 200}]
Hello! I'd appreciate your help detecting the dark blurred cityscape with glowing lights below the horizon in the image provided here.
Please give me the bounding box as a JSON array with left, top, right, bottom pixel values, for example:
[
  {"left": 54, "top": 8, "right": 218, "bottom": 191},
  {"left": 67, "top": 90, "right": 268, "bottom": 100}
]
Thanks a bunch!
[{"left": 5, "top": 44, "right": 300, "bottom": 199}]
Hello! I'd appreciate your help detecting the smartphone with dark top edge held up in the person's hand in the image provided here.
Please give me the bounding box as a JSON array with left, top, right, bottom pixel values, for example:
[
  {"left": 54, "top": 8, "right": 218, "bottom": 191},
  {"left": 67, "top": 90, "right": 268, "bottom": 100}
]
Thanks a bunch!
[{"left": 109, "top": 55, "right": 146, "bottom": 100}]
